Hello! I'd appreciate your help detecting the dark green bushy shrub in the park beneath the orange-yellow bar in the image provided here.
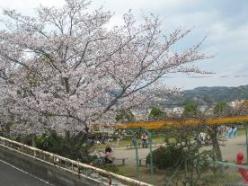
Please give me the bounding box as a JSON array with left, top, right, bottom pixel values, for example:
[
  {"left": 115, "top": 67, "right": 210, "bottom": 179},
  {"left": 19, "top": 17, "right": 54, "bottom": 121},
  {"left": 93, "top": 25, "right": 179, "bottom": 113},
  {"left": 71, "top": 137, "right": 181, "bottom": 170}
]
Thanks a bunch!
[{"left": 146, "top": 127, "right": 211, "bottom": 186}]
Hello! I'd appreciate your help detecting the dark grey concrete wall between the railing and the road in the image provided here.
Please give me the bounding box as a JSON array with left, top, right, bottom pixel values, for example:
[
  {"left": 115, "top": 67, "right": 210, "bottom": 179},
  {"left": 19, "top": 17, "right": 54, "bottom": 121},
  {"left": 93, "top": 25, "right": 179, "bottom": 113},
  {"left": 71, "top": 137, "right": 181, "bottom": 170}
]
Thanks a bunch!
[{"left": 0, "top": 146, "right": 102, "bottom": 186}]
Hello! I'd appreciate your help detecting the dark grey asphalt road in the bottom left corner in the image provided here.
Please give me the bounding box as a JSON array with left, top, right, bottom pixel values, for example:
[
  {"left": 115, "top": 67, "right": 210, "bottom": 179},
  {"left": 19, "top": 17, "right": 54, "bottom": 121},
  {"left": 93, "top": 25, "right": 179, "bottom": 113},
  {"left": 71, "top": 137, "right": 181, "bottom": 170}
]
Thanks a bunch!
[{"left": 0, "top": 160, "right": 51, "bottom": 186}]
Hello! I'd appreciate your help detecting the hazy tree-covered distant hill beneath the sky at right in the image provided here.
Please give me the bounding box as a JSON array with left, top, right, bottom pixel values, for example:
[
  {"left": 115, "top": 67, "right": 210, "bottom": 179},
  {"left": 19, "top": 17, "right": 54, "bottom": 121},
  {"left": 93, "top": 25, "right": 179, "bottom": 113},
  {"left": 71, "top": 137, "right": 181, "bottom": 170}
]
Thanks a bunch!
[{"left": 160, "top": 85, "right": 248, "bottom": 107}]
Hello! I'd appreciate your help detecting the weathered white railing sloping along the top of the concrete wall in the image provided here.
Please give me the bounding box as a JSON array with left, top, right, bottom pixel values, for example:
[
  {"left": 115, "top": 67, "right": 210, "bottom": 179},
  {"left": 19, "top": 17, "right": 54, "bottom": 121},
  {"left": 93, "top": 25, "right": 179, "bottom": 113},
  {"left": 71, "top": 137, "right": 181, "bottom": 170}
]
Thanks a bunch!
[{"left": 0, "top": 136, "right": 152, "bottom": 186}]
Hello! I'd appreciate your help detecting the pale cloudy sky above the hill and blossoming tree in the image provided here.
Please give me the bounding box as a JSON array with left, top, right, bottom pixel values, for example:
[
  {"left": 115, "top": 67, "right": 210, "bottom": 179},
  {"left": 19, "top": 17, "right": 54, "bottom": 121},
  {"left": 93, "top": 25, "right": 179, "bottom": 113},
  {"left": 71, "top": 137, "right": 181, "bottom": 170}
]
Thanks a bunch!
[{"left": 0, "top": 0, "right": 248, "bottom": 89}]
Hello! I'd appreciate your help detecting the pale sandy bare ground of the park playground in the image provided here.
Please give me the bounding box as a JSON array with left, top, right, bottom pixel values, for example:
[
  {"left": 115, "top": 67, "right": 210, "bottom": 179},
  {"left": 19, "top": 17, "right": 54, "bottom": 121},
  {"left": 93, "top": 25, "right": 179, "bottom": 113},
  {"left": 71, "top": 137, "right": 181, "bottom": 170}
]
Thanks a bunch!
[{"left": 114, "top": 136, "right": 246, "bottom": 165}]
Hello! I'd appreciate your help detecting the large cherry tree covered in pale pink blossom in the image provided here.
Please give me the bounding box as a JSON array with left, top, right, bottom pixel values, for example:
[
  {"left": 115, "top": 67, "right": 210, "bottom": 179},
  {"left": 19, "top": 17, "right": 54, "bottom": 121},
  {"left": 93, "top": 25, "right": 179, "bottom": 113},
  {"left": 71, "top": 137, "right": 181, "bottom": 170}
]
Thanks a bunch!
[{"left": 0, "top": 0, "right": 206, "bottom": 132}]
